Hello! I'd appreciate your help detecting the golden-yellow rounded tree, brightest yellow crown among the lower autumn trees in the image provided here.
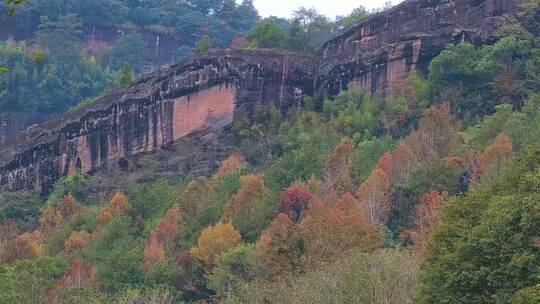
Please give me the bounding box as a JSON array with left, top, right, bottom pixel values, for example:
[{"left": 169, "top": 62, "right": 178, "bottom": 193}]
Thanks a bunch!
[{"left": 191, "top": 222, "right": 242, "bottom": 266}]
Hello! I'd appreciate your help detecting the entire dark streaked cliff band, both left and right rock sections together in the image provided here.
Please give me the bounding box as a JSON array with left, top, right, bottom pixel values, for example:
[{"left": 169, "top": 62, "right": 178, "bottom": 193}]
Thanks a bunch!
[{"left": 0, "top": 0, "right": 520, "bottom": 190}]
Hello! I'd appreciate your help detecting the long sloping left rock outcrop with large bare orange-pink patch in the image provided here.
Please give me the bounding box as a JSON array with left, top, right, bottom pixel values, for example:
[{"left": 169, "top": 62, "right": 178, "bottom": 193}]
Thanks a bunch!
[{"left": 0, "top": 50, "right": 316, "bottom": 189}]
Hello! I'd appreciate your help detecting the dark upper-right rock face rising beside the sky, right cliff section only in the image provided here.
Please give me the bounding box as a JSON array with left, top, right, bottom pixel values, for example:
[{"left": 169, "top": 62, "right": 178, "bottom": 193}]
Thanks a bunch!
[{"left": 318, "top": 0, "right": 521, "bottom": 97}]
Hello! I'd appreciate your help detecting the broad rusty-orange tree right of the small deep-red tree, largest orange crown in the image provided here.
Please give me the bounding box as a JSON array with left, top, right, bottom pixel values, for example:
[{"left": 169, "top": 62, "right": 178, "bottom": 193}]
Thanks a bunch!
[{"left": 300, "top": 193, "right": 380, "bottom": 261}]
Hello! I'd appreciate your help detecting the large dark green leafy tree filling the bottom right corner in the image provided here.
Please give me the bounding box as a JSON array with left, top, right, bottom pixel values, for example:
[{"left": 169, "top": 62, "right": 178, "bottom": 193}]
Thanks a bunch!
[{"left": 421, "top": 146, "right": 540, "bottom": 303}]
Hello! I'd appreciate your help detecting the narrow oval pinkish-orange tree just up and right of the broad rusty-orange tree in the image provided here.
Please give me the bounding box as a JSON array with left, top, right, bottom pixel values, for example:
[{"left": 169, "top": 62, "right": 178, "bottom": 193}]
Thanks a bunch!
[{"left": 357, "top": 168, "right": 392, "bottom": 224}]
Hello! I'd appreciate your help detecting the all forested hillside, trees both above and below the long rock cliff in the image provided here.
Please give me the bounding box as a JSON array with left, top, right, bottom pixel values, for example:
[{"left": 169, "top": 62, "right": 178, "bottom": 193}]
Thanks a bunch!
[{"left": 0, "top": 0, "right": 540, "bottom": 304}]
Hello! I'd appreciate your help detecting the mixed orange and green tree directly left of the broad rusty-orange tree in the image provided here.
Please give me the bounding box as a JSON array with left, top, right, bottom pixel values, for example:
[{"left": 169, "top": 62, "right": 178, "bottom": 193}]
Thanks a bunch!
[{"left": 255, "top": 213, "right": 307, "bottom": 278}]
